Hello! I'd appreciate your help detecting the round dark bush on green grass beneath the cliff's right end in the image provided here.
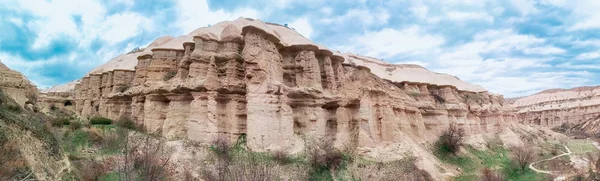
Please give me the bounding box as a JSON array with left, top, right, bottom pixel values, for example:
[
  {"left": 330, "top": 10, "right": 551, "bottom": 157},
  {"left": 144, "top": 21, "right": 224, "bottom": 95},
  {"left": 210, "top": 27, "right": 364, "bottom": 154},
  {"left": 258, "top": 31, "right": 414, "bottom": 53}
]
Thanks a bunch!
[{"left": 436, "top": 124, "right": 465, "bottom": 153}]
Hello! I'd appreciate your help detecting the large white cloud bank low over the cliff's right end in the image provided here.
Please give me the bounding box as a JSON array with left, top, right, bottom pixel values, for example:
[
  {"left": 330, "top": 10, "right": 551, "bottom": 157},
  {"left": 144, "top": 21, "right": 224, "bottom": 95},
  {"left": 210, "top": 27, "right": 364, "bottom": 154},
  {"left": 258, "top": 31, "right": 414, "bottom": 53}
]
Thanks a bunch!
[{"left": 429, "top": 29, "right": 568, "bottom": 97}]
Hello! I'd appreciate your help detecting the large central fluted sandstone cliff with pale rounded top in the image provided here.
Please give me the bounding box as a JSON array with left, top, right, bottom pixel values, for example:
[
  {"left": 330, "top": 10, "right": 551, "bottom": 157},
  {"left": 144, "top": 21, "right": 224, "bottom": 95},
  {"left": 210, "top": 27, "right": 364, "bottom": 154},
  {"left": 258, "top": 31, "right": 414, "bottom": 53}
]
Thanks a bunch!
[{"left": 70, "top": 18, "right": 516, "bottom": 152}]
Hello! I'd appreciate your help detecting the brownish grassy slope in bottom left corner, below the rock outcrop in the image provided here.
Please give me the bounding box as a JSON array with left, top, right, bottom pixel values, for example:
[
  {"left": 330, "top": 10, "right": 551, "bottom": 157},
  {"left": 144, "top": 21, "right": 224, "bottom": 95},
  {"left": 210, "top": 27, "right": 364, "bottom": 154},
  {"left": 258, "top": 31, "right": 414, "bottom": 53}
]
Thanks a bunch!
[{"left": 0, "top": 90, "right": 62, "bottom": 179}]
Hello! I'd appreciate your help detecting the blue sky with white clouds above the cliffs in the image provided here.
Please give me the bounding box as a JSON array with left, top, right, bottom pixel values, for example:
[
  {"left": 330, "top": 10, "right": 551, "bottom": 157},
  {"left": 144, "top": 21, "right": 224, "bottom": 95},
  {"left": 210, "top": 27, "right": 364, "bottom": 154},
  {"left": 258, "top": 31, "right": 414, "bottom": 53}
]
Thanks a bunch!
[{"left": 0, "top": 0, "right": 600, "bottom": 97}]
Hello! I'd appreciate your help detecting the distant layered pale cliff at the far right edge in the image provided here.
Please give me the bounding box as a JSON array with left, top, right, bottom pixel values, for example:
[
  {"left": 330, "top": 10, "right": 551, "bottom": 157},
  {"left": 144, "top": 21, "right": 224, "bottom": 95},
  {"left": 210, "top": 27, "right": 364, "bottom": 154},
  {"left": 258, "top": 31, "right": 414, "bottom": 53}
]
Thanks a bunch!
[{"left": 512, "top": 86, "right": 600, "bottom": 133}]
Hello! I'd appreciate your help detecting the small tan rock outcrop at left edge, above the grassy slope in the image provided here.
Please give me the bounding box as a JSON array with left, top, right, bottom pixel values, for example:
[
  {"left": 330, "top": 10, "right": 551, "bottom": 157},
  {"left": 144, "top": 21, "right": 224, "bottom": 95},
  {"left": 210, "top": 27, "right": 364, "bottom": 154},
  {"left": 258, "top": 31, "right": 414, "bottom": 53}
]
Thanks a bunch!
[{"left": 0, "top": 59, "right": 37, "bottom": 106}]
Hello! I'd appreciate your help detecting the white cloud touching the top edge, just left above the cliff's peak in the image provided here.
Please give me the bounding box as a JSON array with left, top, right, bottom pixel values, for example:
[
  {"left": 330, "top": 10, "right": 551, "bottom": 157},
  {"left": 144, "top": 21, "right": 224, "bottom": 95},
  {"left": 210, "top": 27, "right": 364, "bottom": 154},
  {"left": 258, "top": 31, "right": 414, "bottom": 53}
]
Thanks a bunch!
[{"left": 174, "top": 0, "right": 260, "bottom": 34}]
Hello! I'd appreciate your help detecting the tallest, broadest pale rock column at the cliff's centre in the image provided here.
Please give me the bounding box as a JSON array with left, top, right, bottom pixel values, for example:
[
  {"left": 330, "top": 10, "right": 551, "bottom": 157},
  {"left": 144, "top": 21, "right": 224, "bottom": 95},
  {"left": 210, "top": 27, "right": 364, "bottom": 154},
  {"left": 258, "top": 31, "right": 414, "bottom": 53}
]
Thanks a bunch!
[{"left": 242, "top": 27, "right": 292, "bottom": 151}]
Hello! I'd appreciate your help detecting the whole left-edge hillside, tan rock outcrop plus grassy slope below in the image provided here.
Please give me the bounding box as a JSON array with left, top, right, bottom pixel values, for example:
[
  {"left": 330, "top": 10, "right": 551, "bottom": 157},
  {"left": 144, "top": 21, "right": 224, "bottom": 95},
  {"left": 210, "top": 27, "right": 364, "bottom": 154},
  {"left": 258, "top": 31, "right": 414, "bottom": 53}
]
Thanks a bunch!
[{"left": 0, "top": 63, "right": 63, "bottom": 180}]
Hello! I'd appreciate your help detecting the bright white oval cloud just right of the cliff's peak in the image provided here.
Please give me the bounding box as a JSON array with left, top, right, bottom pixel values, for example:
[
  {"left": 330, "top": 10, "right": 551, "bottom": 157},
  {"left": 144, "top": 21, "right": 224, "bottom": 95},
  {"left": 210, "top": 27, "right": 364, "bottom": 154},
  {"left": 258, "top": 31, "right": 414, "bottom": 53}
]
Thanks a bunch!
[{"left": 340, "top": 26, "right": 444, "bottom": 58}]
